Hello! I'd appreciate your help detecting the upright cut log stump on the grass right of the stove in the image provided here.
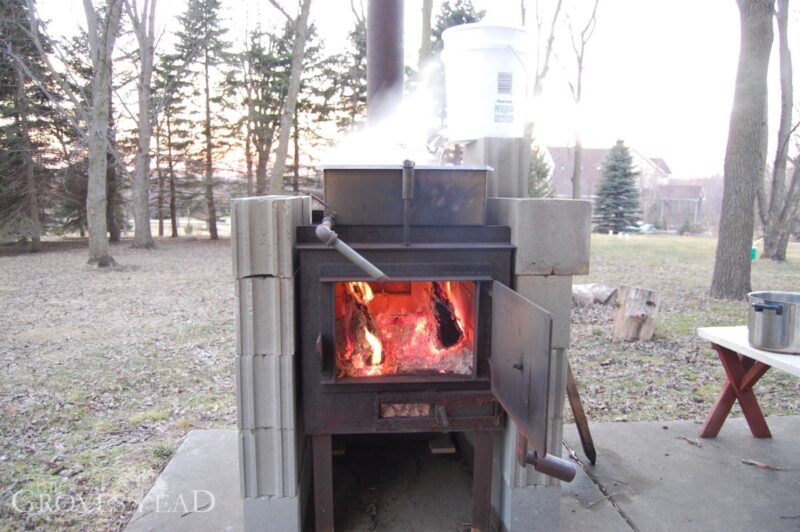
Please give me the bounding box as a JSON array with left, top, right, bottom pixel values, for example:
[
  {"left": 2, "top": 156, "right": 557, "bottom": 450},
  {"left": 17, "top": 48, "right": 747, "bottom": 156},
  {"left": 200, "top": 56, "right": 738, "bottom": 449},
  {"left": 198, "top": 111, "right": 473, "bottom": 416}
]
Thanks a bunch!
[{"left": 612, "top": 285, "right": 661, "bottom": 340}]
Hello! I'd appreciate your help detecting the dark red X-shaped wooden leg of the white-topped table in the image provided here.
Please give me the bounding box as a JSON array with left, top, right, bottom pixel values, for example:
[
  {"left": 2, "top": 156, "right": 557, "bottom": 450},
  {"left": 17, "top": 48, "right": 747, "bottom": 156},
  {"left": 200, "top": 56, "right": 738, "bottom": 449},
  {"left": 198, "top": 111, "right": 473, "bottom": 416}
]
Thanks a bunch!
[{"left": 700, "top": 344, "right": 772, "bottom": 438}]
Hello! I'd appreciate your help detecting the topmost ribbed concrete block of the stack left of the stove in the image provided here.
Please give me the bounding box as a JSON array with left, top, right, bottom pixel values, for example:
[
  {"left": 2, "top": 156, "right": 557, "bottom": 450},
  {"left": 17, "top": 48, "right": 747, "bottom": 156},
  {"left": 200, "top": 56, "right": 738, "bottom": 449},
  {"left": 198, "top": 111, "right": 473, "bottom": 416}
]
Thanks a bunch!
[{"left": 231, "top": 196, "right": 311, "bottom": 279}]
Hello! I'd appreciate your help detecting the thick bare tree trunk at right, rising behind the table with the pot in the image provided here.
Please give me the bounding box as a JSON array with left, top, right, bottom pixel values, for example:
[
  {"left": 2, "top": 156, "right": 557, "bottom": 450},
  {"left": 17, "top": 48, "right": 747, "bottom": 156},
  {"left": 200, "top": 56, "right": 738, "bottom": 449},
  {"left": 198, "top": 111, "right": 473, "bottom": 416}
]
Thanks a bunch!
[{"left": 711, "top": 0, "right": 775, "bottom": 299}]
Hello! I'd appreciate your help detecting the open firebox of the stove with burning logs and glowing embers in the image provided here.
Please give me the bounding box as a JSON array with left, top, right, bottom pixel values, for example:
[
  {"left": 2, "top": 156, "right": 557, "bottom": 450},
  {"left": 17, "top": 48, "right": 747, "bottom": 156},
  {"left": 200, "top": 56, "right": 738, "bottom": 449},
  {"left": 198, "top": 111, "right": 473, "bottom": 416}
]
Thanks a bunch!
[{"left": 334, "top": 281, "right": 478, "bottom": 379}]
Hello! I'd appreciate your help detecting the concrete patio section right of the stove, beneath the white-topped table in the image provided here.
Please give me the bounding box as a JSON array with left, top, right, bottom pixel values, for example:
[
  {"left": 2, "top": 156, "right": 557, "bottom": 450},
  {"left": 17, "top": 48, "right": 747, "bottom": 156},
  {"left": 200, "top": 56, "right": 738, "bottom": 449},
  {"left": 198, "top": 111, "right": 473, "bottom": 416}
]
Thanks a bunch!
[{"left": 564, "top": 416, "right": 800, "bottom": 532}]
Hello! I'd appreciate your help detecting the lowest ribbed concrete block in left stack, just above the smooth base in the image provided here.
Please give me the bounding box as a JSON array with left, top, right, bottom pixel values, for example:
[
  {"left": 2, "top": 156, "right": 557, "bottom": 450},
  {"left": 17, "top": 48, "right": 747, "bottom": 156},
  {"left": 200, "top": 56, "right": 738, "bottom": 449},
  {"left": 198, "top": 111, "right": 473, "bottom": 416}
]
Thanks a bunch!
[{"left": 239, "top": 429, "right": 305, "bottom": 497}]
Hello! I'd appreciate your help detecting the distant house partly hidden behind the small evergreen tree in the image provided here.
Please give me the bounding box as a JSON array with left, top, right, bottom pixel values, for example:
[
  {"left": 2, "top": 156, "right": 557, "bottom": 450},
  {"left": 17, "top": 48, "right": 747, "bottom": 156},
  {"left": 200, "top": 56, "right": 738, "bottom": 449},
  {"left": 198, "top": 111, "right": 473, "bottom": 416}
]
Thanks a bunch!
[{"left": 547, "top": 146, "right": 704, "bottom": 229}]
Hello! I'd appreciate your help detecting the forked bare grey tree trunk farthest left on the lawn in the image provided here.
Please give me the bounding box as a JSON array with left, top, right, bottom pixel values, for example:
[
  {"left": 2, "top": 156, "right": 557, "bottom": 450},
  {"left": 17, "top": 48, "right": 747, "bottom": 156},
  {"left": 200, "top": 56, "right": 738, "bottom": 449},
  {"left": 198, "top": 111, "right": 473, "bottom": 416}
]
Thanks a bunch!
[{"left": 83, "top": 0, "right": 122, "bottom": 267}]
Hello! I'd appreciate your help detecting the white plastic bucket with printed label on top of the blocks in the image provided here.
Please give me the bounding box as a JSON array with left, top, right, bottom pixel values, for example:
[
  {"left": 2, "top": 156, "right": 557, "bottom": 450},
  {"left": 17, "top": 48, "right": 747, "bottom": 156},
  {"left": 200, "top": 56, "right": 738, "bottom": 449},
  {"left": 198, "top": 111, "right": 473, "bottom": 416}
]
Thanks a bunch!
[{"left": 442, "top": 23, "right": 530, "bottom": 141}]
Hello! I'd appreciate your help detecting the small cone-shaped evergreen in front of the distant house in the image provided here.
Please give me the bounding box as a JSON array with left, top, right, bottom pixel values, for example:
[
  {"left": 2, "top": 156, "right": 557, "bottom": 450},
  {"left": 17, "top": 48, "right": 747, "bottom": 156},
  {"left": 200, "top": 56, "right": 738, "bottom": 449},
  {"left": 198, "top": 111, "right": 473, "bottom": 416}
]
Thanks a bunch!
[{"left": 594, "top": 140, "right": 641, "bottom": 233}]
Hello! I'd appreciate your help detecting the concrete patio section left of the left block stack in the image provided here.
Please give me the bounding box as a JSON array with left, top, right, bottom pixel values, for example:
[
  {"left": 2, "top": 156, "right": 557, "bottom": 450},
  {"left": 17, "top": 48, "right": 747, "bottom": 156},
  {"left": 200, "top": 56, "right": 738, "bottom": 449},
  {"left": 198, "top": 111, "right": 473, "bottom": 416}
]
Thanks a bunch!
[{"left": 125, "top": 430, "right": 243, "bottom": 532}]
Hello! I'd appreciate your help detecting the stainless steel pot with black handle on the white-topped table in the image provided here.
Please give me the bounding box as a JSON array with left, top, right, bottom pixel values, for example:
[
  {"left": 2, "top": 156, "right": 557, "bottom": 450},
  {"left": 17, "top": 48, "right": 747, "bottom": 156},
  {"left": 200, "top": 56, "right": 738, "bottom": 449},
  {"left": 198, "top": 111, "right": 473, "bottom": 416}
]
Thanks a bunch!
[{"left": 747, "top": 292, "right": 800, "bottom": 355}]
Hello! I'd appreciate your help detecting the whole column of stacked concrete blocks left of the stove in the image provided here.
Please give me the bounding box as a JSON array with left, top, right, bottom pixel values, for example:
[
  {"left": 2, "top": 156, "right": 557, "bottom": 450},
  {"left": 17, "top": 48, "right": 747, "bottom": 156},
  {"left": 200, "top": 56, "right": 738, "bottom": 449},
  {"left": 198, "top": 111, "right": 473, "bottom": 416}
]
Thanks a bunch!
[{"left": 231, "top": 196, "right": 311, "bottom": 532}]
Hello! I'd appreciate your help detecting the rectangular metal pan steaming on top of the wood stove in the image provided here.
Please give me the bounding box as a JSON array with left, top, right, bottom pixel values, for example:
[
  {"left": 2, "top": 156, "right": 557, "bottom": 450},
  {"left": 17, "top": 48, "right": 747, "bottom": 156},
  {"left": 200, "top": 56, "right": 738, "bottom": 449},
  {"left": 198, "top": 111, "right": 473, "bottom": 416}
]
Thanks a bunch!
[{"left": 322, "top": 164, "right": 491, "bottom": 225}]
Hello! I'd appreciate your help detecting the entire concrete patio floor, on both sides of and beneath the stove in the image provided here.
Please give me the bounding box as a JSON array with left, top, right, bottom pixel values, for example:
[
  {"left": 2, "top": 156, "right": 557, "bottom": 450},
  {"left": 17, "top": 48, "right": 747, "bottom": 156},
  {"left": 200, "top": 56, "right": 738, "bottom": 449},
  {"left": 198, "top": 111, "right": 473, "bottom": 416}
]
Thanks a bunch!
[{"left": 127, "top": 416, "right": 800, "bottom": 532}]
